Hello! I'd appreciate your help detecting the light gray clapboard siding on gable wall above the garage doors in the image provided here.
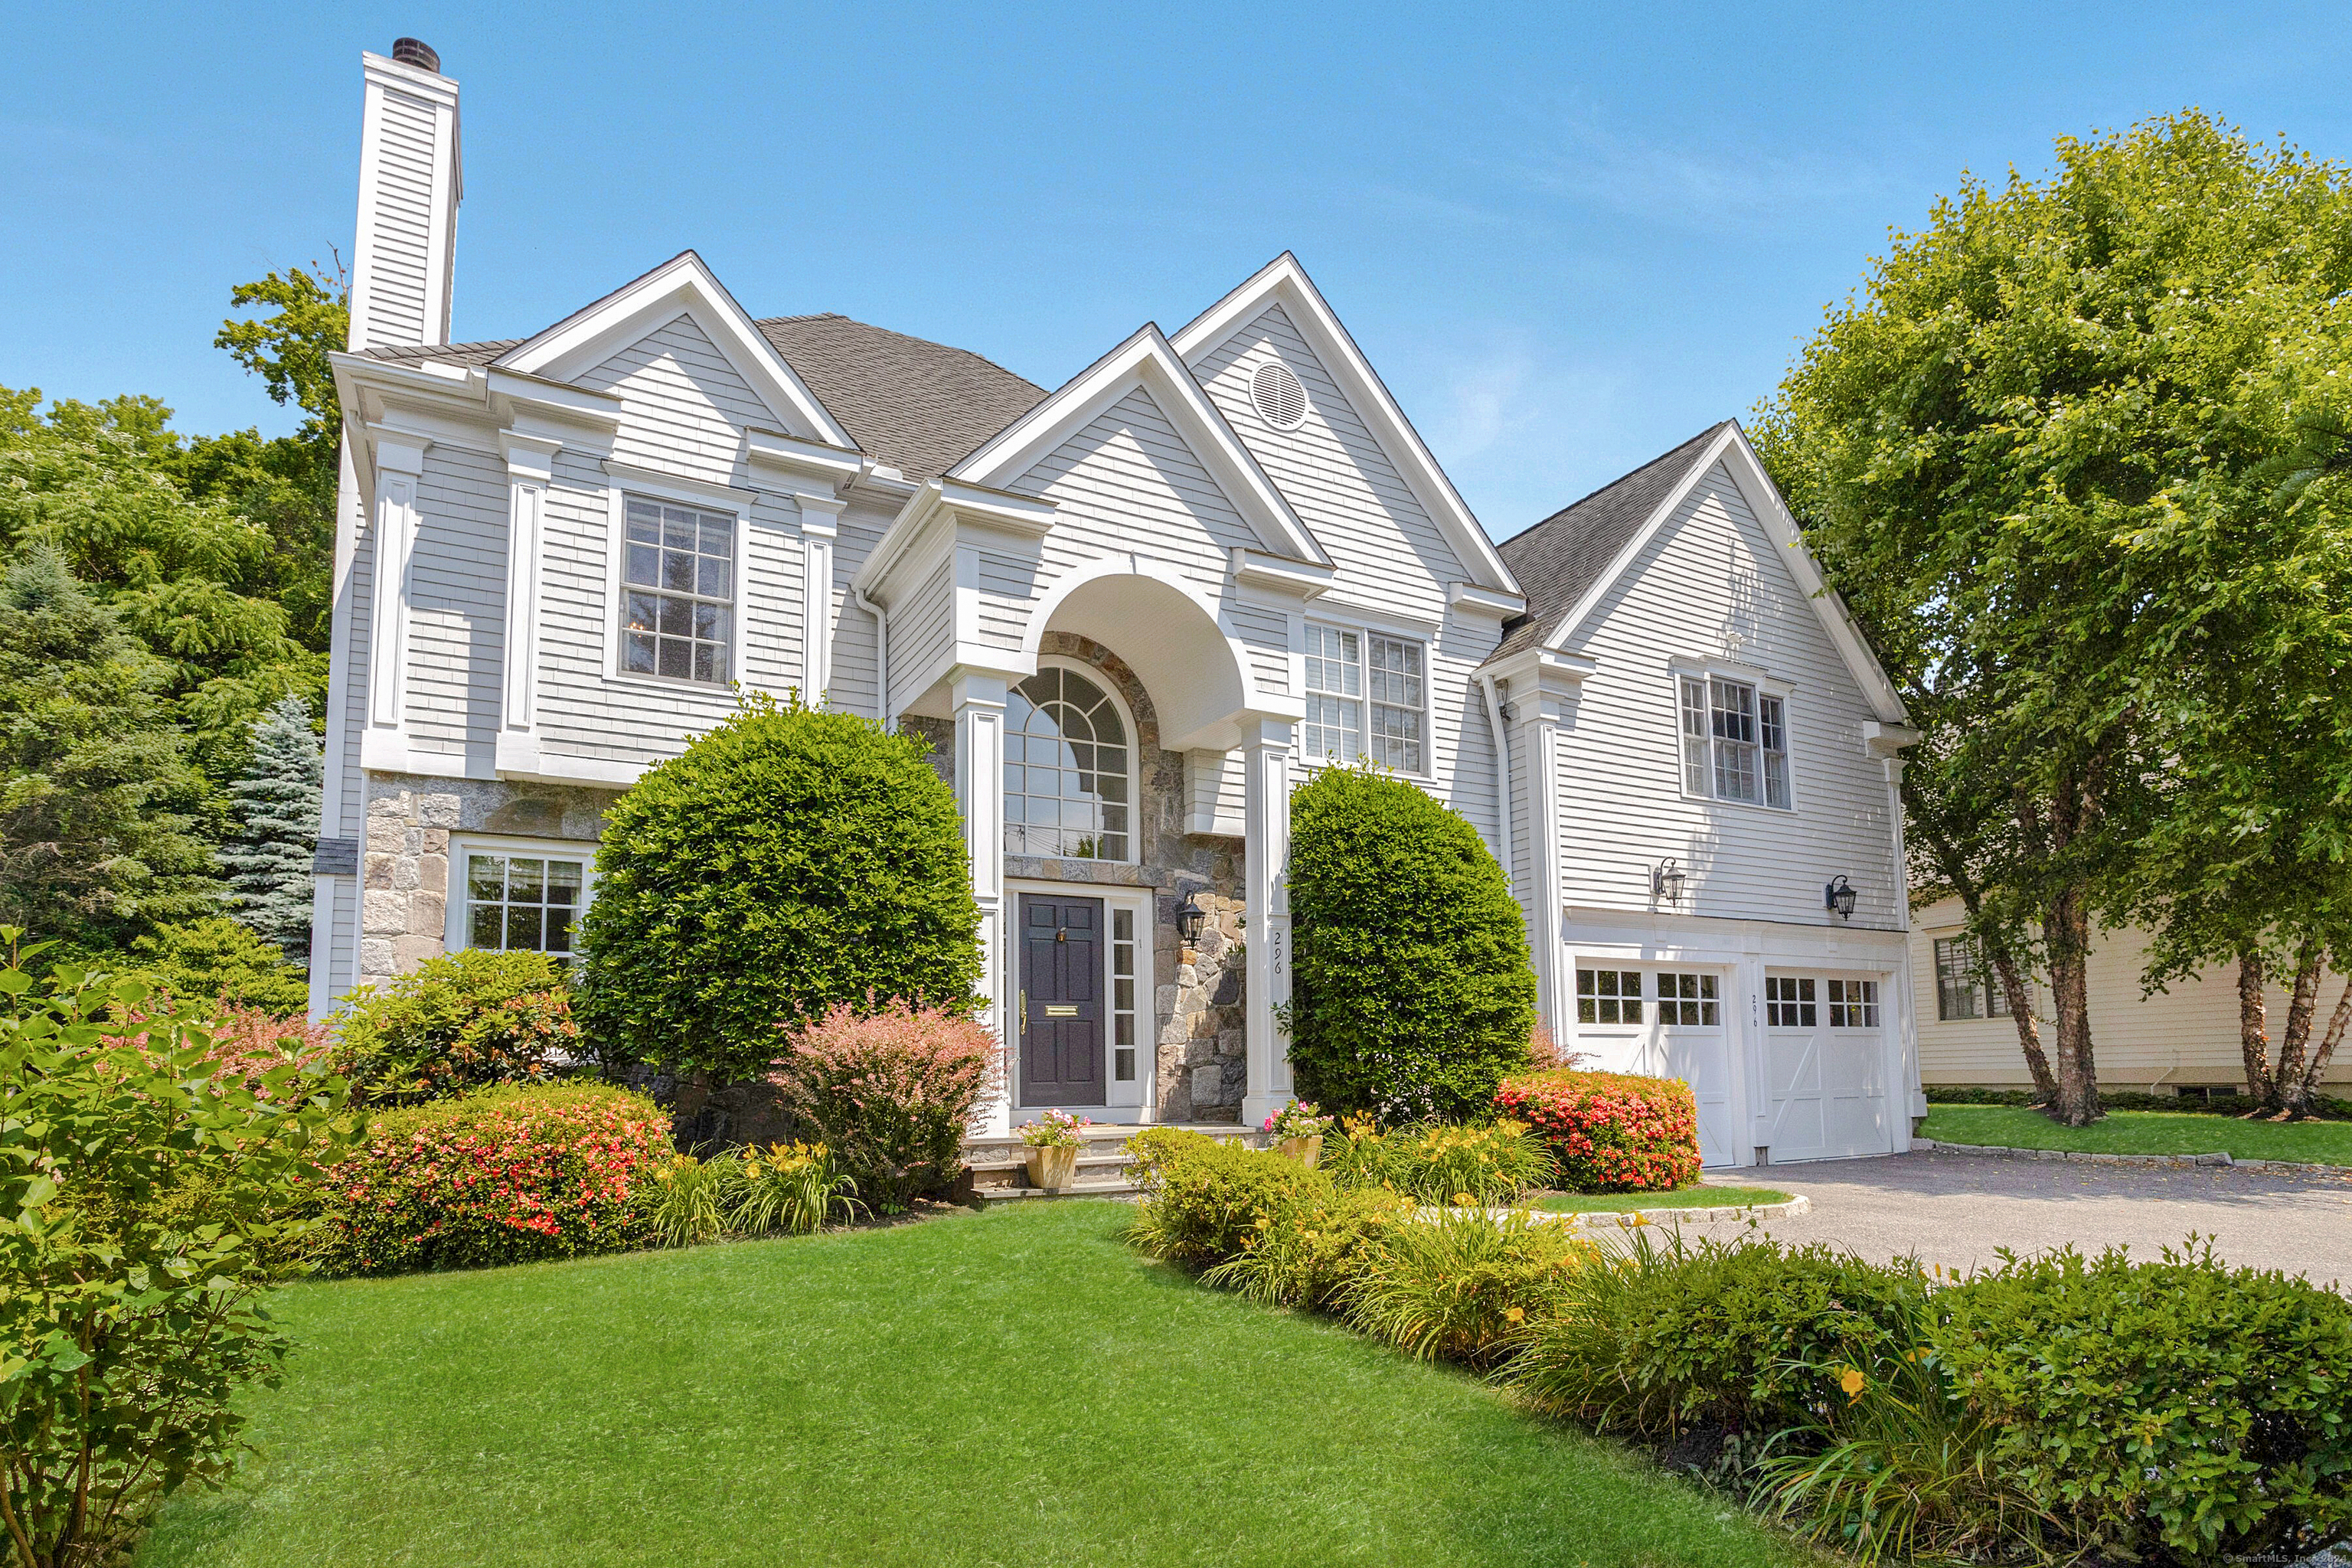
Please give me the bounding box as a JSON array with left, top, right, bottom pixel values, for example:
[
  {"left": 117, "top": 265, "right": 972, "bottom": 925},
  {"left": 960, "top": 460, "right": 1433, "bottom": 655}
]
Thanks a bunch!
[{"left": 1560, "top": 466, "right": 1898, "bottom": 929}]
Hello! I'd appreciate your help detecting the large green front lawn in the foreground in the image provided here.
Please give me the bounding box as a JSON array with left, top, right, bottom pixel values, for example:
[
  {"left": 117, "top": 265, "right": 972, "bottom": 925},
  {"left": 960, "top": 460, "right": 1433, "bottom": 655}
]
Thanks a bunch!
[{"left": 139, "top": 1201, "right": 1816, "bottom": 1568}]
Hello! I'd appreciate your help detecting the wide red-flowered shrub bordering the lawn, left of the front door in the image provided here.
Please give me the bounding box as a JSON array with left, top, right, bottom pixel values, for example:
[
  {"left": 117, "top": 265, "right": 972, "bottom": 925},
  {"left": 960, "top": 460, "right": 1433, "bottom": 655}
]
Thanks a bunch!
[{"left": 320, "top": 1083, "right": 671, "bottom": 1274}]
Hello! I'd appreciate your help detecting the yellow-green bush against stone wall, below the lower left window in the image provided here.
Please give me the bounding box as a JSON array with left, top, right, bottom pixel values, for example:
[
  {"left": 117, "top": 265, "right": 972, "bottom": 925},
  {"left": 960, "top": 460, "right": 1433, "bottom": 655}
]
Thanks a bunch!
[{"left": 334, "top": 947, "right": 581, "bottom": 1105}]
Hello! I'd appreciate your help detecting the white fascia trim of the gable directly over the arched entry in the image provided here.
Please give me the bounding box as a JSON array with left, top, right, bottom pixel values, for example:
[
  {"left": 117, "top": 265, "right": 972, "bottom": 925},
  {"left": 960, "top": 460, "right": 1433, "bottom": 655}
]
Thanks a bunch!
[{"left": 948, "top": 322, "right": 1331, "bottom": 567}]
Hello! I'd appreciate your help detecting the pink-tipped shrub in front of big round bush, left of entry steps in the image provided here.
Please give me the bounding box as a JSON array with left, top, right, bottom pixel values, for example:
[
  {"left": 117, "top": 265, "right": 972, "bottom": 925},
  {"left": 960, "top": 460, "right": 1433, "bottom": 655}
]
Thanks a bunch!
[{"left": 769, "top": 1001, "right": 1000, "bottom": 1213}]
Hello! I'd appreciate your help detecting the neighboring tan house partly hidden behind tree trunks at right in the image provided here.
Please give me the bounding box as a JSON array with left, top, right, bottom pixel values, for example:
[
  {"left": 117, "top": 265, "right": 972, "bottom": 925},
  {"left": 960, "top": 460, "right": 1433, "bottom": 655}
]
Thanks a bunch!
[{"left": 1909, "top": 898, "right": 2352, "bottom": 1096}]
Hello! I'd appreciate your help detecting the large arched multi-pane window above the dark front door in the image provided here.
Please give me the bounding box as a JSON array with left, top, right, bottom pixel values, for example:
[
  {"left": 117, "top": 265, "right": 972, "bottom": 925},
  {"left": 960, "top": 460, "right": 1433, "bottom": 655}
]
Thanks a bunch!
[{"left": 1004, "top": 665, "right": 1134, "bottom": 861}]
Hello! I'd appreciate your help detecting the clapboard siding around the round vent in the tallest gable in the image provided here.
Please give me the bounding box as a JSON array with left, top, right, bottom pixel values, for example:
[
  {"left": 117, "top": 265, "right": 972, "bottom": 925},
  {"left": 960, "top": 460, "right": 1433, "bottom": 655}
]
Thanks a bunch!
[{"left": 1193, "top": 305, "right": 1465, "bottom": 621}]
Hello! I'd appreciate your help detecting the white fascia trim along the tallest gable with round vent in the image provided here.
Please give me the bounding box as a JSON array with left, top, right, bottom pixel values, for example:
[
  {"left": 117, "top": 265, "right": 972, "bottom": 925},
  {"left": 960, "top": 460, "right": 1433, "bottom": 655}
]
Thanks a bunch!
[{"left": 1171, "top": 252, "right": 1520, "bottom": 593}]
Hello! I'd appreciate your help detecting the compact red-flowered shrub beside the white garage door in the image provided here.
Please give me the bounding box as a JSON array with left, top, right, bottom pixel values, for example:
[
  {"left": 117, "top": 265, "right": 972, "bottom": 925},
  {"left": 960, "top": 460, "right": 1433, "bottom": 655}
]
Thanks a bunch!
[{"left": 1494, "top": 1070, "right": 1698, "bottom": 1192}]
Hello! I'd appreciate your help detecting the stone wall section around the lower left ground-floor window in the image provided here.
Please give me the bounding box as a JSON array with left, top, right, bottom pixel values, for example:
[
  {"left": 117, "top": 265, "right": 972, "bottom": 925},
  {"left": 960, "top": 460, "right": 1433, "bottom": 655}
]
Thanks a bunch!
[{"left": 360, "top": 773, "right": 619, "bottom": 982}]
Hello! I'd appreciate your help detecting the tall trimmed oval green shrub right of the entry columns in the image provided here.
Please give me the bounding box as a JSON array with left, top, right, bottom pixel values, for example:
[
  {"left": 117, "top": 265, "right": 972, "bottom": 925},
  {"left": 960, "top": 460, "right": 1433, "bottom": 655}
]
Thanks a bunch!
[{"left": 1289, "top": 766, "right": 1536, "bottom": 1122}]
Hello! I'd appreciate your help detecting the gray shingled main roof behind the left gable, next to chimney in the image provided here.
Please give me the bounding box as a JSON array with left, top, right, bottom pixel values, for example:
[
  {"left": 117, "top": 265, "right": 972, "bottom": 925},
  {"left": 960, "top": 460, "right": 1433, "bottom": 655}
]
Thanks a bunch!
[{"left": 367, "top": 315, "right": 1044, "bottom": 479}]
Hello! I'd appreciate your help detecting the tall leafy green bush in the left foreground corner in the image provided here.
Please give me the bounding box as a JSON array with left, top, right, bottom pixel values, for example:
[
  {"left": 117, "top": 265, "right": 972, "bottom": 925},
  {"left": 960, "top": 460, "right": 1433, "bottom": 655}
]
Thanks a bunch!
[{"left": 0, "top": 929, "right": 351, "bottom": 1563}]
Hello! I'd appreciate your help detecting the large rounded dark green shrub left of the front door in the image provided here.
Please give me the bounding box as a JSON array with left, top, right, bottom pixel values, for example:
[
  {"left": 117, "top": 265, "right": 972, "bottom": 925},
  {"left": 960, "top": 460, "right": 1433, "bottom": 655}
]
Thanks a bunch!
[{"left": 581, "top": 696, "right": 981, "bottom": 1086}]
